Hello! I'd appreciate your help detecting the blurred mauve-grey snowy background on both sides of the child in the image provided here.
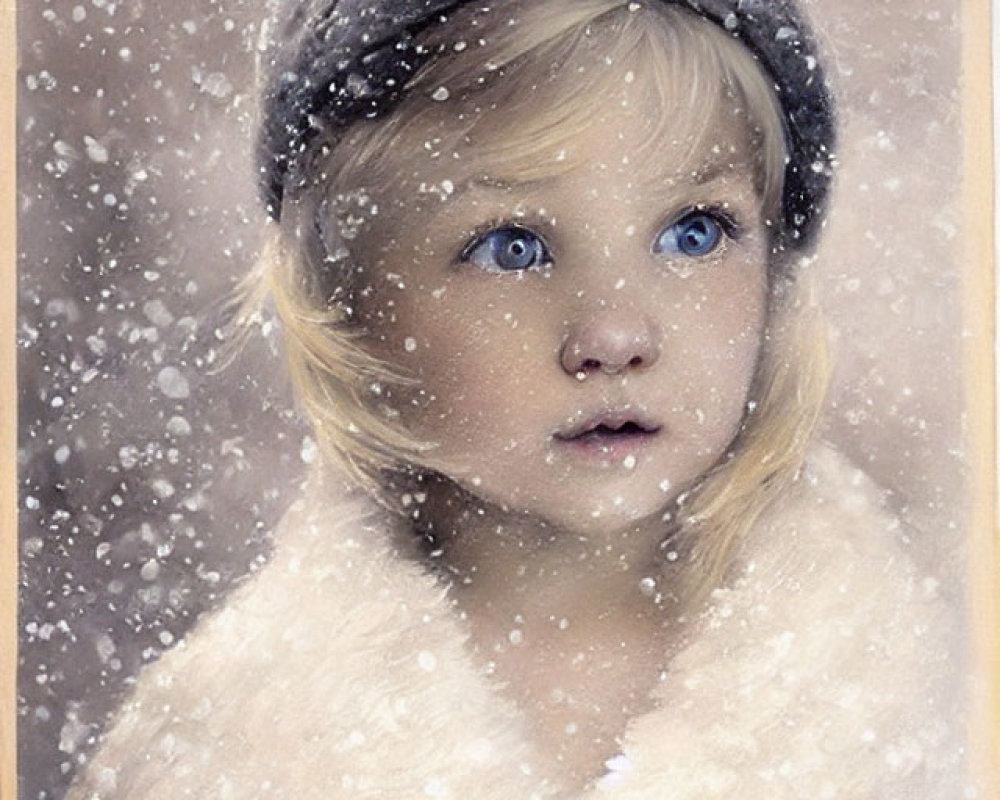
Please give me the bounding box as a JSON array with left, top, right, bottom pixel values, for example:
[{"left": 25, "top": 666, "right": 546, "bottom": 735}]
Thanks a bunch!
[{"left": 18, "top": 0, "right": 964, "bottom": 800}]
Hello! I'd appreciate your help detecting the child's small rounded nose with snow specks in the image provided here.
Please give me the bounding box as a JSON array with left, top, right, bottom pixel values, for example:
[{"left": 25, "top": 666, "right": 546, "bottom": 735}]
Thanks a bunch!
[{"left": 559, "top": 309, "right": 660, "bottom": 376}]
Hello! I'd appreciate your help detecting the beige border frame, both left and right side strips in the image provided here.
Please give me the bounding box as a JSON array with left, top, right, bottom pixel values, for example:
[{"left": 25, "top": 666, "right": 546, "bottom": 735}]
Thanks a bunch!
[{"left": 0, "top": 0, "right": 1000, "bottom": 800}]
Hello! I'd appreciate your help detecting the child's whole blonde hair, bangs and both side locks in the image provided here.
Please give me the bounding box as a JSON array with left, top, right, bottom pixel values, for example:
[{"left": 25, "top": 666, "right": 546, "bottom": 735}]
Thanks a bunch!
[{"left": 248, "top": 0, "right": 827, "bottom": 598}]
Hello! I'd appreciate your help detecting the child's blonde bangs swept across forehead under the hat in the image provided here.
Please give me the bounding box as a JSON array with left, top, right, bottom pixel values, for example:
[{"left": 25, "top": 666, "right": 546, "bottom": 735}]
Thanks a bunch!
[{"left": 322, "top": 0, "right": 786, "bottom": 219}]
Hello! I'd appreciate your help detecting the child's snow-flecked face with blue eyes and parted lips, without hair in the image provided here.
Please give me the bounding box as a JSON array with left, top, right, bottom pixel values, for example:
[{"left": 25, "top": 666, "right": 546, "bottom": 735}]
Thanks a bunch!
[{"left": 357, "top": 86, "right": 768, "bottom": 531}]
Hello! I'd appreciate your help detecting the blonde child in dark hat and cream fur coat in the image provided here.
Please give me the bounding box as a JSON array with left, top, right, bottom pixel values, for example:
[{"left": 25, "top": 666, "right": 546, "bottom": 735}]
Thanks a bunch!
[{"left": 70, "top": 0, "right": 965, "bottom": 800}]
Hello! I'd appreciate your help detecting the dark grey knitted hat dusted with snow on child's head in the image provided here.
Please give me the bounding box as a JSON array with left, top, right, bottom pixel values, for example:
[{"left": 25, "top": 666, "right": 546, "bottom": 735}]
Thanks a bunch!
[{"left": 257, "top": 0, "right": 836, "bottom": 249}]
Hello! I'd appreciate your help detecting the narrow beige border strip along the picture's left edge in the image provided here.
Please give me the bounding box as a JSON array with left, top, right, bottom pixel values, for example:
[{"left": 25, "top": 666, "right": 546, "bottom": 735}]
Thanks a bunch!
[{"left": 0, "top": 0, "right": 17, "bottom": 800}]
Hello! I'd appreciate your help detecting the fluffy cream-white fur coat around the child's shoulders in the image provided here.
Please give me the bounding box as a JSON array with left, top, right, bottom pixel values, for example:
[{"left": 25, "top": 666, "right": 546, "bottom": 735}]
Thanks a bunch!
[{"left": 69, "top": 447, "right": 966, "bottom": 800}]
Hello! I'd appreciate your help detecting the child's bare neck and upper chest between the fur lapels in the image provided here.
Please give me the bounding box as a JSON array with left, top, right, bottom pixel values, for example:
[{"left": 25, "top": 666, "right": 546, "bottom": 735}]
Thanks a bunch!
[{"left": 414, "top": 476, "right": 679, "bottom": 786}]
